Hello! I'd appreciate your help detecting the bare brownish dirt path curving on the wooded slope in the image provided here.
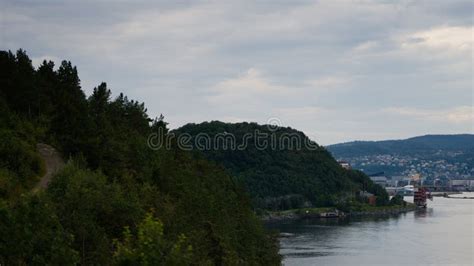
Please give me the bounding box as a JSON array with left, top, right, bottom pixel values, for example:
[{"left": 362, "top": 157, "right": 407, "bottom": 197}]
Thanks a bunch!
[{"left": 34, "top": 143, "right": 64, "bottom": 191}]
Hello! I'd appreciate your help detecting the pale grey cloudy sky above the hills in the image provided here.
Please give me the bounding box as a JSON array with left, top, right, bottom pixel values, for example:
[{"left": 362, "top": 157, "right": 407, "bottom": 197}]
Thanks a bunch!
[{"left": 0, "top": 0, "right": 474, "bottom": 144}]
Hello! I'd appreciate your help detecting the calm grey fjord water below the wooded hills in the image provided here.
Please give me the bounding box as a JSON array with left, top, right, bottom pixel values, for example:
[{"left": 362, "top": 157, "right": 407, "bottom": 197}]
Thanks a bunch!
[{"left": 269, "top": 193, "right": 474, "bottom": 265}]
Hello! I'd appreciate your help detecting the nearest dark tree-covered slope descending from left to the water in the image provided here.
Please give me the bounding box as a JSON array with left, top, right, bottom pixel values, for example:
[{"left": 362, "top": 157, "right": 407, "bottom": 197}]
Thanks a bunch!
[{"left": 0, "top": 50, "right": 282, "bottom": 265}]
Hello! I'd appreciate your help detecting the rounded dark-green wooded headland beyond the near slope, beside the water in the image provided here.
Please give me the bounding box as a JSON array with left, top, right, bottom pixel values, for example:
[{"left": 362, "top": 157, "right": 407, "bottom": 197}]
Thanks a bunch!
[{"left": 174, "top": 121, "right": 389, "bottom": 210}]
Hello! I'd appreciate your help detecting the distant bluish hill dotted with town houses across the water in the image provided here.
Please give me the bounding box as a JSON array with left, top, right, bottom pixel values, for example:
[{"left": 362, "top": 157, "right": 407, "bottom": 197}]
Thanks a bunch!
[{"left": 327, "top": 134, "right": 474, "bottom": 178}]
